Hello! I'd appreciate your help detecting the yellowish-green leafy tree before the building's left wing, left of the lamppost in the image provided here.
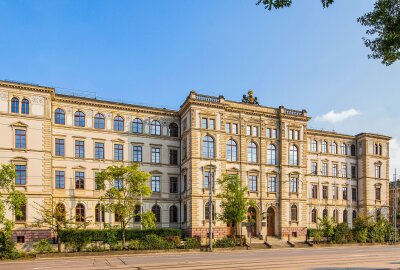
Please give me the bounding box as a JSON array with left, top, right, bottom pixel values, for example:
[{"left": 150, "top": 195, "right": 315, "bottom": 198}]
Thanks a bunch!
[{"left": 96, "top": 164, "right": 151, "bottom": 248}]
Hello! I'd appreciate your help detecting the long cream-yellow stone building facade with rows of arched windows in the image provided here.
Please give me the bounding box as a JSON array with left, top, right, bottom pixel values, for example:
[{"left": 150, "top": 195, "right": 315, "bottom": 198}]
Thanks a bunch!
[{"left": 0, "top": 81, "right": 390, "bottom": 241}]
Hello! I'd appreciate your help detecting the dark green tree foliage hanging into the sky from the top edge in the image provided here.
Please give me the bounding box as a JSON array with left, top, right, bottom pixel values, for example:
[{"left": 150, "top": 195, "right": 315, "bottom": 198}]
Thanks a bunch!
[{"left": 257, "top": 0, "right": 400, "bottom": 66}]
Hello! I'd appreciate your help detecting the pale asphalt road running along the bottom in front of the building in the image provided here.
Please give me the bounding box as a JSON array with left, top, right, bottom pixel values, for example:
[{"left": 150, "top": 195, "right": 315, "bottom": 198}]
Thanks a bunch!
[{"left": 0, "top": 246, "right": 400, "bottom": 270}]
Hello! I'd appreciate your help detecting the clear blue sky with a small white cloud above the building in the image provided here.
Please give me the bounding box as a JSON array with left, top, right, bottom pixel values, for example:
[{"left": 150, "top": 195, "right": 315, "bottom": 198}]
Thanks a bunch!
[{"left": 0, "top": 0, "right": 400, "bottom": 177}]
